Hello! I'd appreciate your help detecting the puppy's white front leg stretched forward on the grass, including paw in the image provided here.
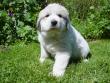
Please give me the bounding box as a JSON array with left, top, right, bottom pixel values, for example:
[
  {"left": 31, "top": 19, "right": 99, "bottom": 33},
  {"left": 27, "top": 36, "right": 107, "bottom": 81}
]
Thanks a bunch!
[{"left": 52, "top": 52, "right": 70, "bottom": 77}]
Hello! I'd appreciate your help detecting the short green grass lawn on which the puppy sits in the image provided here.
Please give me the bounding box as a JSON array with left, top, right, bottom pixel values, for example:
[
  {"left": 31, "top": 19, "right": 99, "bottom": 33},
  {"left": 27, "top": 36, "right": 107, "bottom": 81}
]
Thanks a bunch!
[{"left": 0, "top": 40, "right": 110, "bottom": 83}]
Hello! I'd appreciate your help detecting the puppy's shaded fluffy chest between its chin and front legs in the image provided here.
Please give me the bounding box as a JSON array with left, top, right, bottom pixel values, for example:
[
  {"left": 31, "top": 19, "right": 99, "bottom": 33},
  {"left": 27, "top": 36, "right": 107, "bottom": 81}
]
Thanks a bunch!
[{"left": 42, "top": 34, "right": 71, "bottom": 55}]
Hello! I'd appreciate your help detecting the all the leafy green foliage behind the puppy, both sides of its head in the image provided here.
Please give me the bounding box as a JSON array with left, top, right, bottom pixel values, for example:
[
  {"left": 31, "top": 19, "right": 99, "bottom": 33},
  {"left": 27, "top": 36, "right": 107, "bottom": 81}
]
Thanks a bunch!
[{"left": 0, "top": 0, "right": 110, "bottom": 45}]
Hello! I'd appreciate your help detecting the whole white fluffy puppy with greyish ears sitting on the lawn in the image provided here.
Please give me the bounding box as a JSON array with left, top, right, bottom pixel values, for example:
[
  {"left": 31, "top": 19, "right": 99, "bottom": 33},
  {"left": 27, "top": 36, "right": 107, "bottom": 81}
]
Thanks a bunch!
[{"left": 37, "top": 3, "right": 90, "bottom": 77}]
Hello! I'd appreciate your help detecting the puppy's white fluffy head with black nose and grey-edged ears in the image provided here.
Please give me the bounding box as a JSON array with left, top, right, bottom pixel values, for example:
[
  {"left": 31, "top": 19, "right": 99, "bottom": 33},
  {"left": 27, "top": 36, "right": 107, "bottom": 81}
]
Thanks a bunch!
[{"left": 37, "top": 3, "right": 69, "bottom": 32}]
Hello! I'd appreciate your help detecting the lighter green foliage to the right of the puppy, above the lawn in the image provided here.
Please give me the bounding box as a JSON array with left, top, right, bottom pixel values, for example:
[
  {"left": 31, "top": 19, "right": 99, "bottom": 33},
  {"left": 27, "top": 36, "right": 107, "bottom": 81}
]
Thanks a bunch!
[{"left": 64, "top": 0, "right": 110, "bottom": 39}]
